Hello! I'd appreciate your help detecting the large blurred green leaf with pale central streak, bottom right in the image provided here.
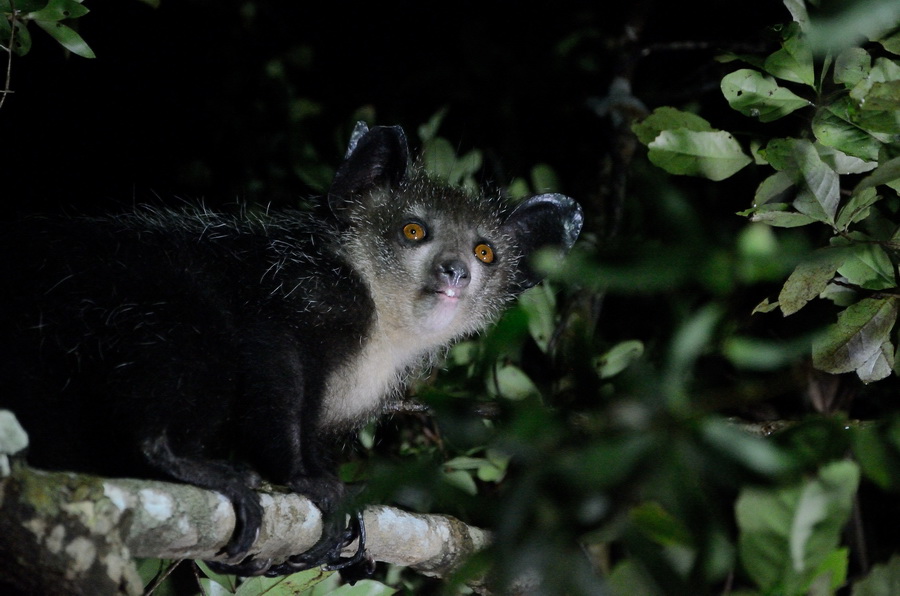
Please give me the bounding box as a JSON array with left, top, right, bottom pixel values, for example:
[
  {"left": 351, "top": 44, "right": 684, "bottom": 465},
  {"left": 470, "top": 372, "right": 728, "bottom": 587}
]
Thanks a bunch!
[{"left": 735, "top": 461, "right": 859, "bottom": 596}]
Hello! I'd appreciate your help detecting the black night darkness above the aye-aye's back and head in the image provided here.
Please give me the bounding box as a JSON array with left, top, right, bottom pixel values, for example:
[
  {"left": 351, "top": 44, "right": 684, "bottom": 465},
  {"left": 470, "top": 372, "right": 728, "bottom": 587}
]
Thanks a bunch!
[{"left": 0, "top": 0, "right": 789, "bottom": 212}]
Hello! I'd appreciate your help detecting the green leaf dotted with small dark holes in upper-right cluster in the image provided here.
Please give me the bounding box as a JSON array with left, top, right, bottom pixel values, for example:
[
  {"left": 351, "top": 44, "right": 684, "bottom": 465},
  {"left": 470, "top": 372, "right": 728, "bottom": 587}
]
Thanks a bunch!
[{"left": 722, "top": 68, "right": 812, "bottom": 122}]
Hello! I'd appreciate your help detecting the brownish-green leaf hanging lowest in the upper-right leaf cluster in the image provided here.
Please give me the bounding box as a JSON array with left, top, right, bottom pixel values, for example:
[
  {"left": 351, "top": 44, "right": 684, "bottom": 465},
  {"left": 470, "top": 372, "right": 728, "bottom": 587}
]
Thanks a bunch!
[{"left": 813, "top": 298, "right": 897, "bottom": 382}]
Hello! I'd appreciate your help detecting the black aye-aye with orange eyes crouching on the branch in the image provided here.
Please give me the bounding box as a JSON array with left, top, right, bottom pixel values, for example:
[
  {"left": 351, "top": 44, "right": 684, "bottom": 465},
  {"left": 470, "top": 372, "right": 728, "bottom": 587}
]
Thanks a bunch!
[{"left": 0, "top": 123, "right": 582, "bottom": 572}]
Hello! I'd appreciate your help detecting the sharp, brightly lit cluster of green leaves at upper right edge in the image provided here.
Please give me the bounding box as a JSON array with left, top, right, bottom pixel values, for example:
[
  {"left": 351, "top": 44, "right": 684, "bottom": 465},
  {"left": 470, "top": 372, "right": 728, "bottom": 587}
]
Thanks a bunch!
[{"left": 635, "top": 3, "right": 900, "bottom": 382}]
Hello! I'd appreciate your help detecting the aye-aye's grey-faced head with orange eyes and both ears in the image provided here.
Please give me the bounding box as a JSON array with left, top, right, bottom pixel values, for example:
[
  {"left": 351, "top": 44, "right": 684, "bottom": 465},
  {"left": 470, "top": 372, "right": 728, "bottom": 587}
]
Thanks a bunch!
[{"left": 328, "top": 122, "right": 583, "bottom": 344}]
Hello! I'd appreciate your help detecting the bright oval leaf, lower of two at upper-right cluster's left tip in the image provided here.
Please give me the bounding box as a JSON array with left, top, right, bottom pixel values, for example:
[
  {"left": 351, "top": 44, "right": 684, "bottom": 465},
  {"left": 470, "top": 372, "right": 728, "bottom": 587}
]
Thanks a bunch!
[{"left": 648, "top": 128, "right": 752, "bottom": 180}]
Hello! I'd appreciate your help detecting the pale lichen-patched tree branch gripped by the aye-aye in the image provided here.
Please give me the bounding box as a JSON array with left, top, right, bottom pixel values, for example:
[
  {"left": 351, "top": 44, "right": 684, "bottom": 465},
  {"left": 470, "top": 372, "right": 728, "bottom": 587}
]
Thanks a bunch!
[{"left": 0, "top": 412, "right": 488, "bottom": 594}]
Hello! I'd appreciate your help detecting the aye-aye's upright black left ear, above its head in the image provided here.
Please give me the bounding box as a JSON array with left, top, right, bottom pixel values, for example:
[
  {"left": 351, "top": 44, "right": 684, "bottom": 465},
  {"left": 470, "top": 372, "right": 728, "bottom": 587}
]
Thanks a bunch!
[{"left": 328, "top": 122, "right": 409, "bottom": 220}]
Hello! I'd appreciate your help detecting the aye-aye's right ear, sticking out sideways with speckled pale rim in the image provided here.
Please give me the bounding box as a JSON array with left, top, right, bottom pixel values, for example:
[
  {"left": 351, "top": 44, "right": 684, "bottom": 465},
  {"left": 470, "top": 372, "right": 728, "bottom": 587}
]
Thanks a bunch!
[{"left": 501, "top": 193, "right": 584, "bottom": 292}]
